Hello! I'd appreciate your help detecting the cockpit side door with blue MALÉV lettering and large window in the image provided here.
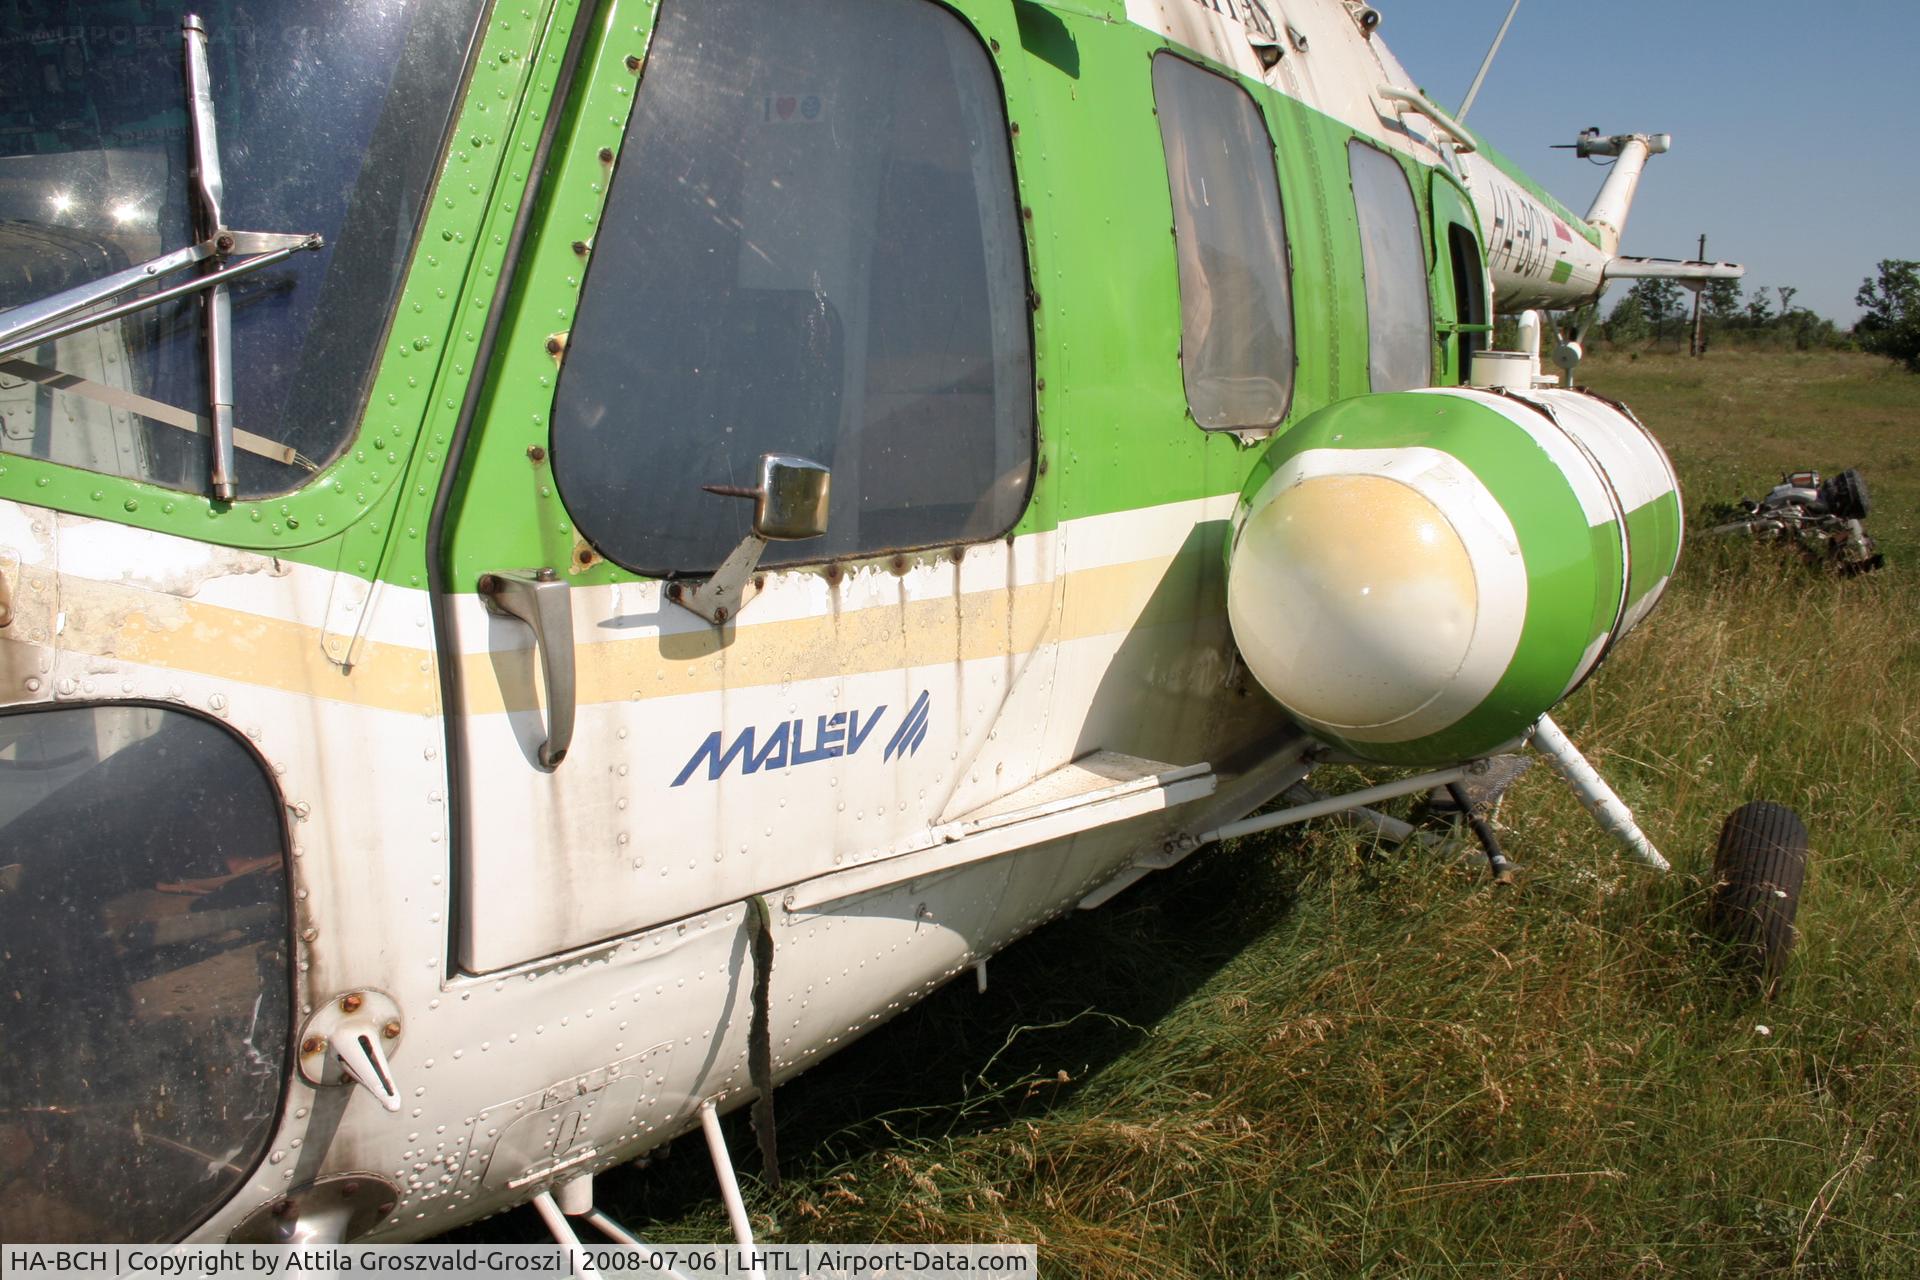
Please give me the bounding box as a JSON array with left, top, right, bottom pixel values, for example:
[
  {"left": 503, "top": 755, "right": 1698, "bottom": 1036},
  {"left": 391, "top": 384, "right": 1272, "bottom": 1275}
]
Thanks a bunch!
[{"left": 436, "top": 0, "right": 1058, "bottom": 971}]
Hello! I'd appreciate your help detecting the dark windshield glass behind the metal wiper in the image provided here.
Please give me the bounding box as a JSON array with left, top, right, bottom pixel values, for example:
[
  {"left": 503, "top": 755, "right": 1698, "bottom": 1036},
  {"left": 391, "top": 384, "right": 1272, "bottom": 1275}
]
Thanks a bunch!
[{"left": 0, "top": 0, "right": 482, "bottom": 495}]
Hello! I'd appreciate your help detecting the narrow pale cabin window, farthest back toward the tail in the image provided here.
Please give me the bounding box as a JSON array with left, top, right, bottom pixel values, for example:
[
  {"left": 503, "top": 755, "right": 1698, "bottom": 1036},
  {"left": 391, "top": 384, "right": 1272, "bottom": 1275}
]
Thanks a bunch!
[{"left": 1346, "top": 140, "right": 1434, "bottom": 391}]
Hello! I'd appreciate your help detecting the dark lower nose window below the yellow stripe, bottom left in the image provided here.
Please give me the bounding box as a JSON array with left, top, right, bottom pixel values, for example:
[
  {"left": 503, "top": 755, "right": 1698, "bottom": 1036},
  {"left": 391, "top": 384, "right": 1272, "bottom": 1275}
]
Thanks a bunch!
[{"left": 0, "top": 706, "right": 290, "bottom": 1242}]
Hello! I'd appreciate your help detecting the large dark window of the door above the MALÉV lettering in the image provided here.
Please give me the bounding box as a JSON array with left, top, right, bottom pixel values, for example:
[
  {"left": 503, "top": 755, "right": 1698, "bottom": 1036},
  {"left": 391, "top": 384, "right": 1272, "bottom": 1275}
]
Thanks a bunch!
[{"left": 553, "top": 0, "right": 1033, "bottom": 574}]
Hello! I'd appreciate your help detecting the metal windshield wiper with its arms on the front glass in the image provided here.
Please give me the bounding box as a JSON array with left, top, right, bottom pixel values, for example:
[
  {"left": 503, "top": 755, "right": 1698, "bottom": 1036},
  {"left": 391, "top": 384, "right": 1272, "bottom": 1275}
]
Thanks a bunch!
[{"left": 0, "top": 13, "right": 324, "bottom": 503}]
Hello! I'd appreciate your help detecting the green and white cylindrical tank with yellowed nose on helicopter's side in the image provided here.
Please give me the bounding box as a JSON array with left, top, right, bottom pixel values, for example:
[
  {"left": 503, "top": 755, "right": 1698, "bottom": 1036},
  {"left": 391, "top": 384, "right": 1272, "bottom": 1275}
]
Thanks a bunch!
[{"left": 1227, "top": 388, "right": 1682, "bottom": 764}]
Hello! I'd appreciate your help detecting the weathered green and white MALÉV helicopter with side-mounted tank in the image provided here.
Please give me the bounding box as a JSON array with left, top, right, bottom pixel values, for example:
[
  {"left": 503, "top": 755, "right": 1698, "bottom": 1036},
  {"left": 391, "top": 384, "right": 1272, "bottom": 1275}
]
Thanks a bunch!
[{"left": 0, "top": 0, "right": 1781, "bottom": 1244}]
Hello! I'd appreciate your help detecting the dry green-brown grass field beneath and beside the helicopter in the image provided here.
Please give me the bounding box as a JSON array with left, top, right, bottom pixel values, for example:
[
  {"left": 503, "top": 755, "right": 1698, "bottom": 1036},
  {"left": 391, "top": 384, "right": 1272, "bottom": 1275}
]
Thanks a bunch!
[{"left": 456, "top": 353, "right": 1920, "bottom": 1278}]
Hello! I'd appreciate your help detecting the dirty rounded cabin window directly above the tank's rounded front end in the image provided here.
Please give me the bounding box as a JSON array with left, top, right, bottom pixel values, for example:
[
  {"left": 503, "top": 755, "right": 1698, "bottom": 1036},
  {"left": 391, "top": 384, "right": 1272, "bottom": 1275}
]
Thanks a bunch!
[{"left": 1154, "top": 54, "right": 1294, "bottom": 428}]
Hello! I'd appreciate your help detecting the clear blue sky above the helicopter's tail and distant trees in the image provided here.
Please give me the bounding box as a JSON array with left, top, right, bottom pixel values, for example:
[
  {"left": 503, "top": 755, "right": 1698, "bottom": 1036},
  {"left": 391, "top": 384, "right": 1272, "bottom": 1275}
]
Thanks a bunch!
[{"left": 1375, "top": 0, "right": 1920, "bottom": 324}]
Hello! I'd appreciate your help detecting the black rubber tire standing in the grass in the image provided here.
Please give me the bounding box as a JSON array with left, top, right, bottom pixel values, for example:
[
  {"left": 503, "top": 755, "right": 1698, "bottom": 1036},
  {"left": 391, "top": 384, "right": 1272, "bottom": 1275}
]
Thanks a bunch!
[{"left": 1707, "top": 800, "right": 1807, "bottom": 990}]
